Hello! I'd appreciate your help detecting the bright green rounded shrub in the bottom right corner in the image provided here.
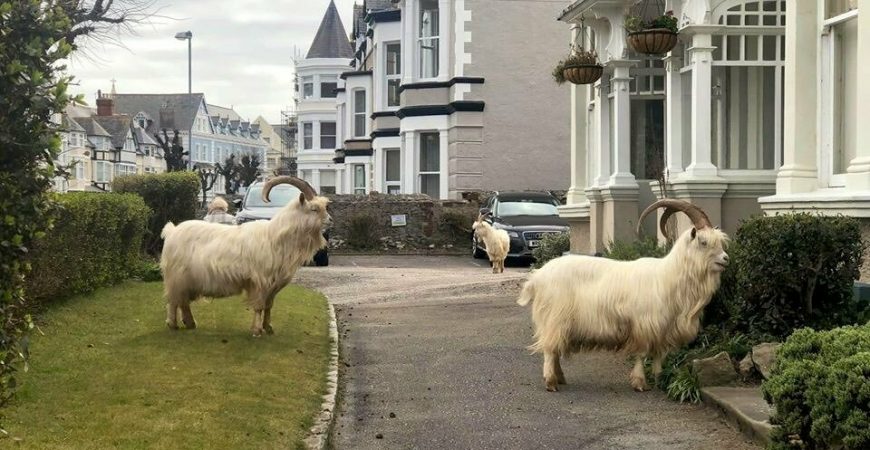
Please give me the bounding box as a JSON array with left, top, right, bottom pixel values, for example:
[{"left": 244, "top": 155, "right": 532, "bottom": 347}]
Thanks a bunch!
[{"left": 762, "top": 325, "right": 870, "bottom": 450}]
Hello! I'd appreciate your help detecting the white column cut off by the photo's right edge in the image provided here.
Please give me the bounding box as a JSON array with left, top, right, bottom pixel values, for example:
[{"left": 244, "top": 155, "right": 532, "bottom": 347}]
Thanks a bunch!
[{"left": 846, "top": 6, "right": 870, "bottom": 191}]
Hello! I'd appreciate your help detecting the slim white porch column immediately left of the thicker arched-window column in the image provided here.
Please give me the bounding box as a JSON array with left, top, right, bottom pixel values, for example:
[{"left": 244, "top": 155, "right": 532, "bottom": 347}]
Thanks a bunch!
[{"left": 665, "top": 52, "right": 684, "bottom": 178}]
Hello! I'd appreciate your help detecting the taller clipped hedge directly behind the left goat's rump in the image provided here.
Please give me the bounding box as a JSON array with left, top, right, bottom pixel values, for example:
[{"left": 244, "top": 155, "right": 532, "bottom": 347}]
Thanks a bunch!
[{"left": 112, "top": 172, "right": 200, "bottom": 255}]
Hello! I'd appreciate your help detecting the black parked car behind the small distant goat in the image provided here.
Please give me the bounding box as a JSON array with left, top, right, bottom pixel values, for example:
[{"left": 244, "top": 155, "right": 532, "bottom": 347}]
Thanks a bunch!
[{"left": 471, "top": 192, "right": 568, "bottom": 259}]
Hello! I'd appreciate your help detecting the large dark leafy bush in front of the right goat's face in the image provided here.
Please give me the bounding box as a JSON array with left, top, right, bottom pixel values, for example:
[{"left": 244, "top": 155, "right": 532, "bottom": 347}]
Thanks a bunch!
[{"left": 720, "top": 214, "right": 865, "bottom": 338}]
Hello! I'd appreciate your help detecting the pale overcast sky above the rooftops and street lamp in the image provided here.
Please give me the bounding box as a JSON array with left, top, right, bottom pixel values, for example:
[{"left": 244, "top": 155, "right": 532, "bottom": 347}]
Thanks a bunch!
[{"left": 68, "top": 0, "right": 354, "bottom": 123}]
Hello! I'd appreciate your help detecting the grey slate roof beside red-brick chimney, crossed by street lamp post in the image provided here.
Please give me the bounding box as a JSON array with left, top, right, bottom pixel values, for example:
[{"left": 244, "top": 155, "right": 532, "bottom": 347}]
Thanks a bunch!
[{"left": 115, "top": 93, "right": 204, "bottom": 132}]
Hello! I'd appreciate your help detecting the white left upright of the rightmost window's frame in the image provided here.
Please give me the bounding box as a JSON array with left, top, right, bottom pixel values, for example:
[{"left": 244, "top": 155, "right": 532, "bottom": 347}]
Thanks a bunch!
[{"left": 819, "top": 7, "right": 861, "bottom": 188}]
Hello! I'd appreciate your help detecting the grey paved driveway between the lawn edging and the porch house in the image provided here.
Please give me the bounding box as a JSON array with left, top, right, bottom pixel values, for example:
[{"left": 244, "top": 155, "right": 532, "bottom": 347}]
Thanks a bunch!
[{"left": 298, "top": 256, "right": 757, "bottom": 450}]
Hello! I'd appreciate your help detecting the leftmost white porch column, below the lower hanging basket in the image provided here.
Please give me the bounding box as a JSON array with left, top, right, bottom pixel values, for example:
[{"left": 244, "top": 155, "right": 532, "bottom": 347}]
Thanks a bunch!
[{"left": 566, "top": 24, "right": 590, "bottom": 205}]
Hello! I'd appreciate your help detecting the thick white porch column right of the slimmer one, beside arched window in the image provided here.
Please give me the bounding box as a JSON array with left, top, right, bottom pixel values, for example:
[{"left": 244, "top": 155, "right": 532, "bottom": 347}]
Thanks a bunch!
[{"left": 685, "top": 32, "right": 718, "bottom": 178}]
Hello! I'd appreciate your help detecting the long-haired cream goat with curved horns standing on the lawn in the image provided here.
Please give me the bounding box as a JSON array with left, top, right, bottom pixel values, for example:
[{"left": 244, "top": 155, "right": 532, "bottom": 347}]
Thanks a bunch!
[{"left": 160, "top": 176, "right": 332, "bottom": 336}]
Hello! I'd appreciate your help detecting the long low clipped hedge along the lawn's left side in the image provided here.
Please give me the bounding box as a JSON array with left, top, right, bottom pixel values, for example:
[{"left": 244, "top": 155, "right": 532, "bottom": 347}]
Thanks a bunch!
[{"left": 25, "top": 193, "right": 150, "bottom": 306}]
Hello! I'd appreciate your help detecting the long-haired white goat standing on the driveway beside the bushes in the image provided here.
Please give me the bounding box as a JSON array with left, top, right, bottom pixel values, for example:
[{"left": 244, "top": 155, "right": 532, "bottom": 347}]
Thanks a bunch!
[{"left": 517, "top": 199, "right": 728, "bottom": 391}]
